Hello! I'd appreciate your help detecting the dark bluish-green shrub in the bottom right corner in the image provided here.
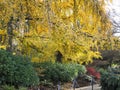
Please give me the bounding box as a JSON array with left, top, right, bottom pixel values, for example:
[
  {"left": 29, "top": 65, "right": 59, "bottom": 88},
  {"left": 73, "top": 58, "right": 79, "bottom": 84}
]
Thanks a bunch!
[{"left": 101, "top": 68, "right": 120, "bottom": 90}]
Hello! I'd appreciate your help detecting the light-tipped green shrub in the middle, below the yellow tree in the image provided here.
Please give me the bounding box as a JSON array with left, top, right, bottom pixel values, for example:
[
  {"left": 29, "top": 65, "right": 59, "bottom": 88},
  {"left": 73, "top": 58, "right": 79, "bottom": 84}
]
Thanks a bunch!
[{"left": 35, "top": 62, "right": 86, "bottom": 83}]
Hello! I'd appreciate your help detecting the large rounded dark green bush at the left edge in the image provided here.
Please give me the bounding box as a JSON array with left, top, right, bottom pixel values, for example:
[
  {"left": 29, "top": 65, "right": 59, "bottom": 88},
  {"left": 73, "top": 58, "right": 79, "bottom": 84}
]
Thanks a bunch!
[{"left": 0, "top": 50, "right": 39, "bottom": 86}]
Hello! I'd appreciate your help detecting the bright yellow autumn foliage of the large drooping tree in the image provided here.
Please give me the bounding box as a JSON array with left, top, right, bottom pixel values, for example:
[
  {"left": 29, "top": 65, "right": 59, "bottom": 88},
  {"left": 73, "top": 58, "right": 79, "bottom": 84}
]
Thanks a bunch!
[{"left": 0, "top": 0, "right": 116, "bottom": 64}]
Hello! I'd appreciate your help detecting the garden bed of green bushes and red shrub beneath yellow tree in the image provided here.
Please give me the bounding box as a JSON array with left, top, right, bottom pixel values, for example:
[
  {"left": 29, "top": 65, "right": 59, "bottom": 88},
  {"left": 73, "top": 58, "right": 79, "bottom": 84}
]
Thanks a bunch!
[{"left": 0, "top": 50, "right": 120, "bottom": 90}]
